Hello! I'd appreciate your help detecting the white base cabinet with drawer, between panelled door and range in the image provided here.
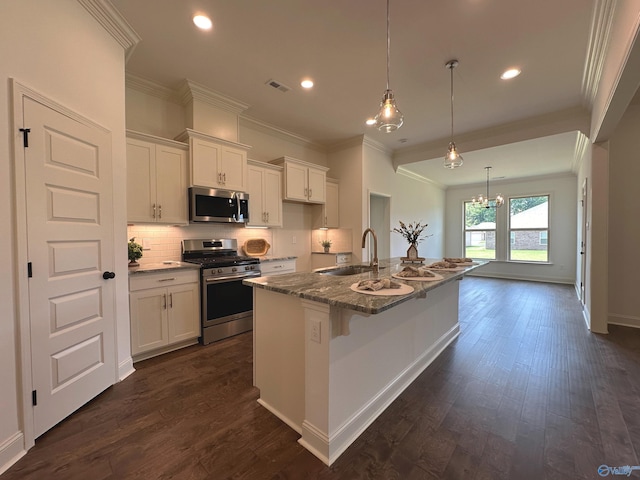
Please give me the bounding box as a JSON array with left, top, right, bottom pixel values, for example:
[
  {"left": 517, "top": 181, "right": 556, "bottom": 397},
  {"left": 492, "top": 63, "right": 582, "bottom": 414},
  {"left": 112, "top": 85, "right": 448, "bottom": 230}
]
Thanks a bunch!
[{"left": 129, "top": 269, "right": 200, "bottom": 361}]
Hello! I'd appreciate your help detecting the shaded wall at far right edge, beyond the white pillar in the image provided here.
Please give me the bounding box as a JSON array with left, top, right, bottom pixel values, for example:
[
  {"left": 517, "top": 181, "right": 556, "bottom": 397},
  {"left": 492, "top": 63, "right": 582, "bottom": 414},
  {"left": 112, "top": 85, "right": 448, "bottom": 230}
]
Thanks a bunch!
[{"left": 608, "top": 105, "right": 640, "bottom": 327}]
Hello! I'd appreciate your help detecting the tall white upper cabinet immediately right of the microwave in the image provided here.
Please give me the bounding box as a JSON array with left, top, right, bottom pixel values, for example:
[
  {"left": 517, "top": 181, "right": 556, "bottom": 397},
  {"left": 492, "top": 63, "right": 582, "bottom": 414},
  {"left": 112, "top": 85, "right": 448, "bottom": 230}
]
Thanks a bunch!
[{"left": 247, "top": 160, "right": 282, "bottom": 227}]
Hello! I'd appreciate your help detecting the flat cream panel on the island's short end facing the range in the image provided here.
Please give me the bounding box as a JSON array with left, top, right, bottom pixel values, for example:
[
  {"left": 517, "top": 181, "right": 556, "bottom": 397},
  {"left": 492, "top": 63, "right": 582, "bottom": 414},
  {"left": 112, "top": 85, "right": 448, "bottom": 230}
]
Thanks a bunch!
[{"left": 253, "top": 288, "right": 305, "bottom": 433}]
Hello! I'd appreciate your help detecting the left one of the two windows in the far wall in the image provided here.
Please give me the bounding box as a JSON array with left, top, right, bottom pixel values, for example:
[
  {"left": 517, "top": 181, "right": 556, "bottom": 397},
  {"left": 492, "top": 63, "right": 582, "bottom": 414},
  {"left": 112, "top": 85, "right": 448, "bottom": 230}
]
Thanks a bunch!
[{"left": 464, "top": 202, "right": 496, "bottom": 260}]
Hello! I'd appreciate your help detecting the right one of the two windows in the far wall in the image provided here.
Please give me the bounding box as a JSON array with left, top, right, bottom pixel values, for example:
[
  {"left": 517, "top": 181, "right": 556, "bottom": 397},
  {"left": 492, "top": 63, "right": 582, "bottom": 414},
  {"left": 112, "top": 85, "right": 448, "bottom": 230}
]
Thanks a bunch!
[{"left": 509, "top": 195, "right": 549, "bottom": 262}]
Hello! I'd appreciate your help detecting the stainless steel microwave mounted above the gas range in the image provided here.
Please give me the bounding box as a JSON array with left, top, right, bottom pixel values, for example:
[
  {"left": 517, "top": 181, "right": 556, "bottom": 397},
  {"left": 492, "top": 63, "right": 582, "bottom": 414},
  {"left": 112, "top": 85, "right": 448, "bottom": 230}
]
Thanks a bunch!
[{"left": 189, "top": 187, "right": 249, "bottom": 223}]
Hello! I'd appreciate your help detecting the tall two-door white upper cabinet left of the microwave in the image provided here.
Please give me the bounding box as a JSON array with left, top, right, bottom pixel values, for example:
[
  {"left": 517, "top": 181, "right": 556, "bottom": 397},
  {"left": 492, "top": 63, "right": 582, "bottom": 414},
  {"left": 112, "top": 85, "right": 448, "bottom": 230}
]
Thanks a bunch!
[{"left": 127, "top": 130, "right": 189, "bottom": 225}]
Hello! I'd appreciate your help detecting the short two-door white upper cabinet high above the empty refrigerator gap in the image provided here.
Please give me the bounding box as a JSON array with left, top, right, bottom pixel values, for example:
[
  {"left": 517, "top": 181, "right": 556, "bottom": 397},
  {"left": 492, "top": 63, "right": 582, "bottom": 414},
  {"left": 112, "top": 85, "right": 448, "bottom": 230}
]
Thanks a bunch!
[{"left": 270, "top": 157, "right": 329, "bottom": 203}]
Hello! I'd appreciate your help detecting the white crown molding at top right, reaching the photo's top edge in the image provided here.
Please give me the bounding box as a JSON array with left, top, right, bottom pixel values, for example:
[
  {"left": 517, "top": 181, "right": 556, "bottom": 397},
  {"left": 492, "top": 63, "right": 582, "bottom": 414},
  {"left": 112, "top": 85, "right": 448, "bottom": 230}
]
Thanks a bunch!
[{"left": 582, "top": 0, "right": 616, "bottom": 110}]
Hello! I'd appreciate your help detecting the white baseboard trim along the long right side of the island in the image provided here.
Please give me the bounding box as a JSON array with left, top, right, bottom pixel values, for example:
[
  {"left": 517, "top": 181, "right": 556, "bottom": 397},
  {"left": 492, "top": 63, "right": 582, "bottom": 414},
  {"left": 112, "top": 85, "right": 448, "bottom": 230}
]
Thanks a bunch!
[{"left": 298, "top": 323, "right": 460, "bottom": 466}]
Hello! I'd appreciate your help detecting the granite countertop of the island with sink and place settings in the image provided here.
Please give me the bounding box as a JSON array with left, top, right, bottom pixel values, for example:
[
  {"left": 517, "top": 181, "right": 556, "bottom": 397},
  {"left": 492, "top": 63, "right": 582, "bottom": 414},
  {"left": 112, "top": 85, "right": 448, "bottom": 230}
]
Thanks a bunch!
[{"left": 243, "top": 258, "right": 488, "bottom": 314}]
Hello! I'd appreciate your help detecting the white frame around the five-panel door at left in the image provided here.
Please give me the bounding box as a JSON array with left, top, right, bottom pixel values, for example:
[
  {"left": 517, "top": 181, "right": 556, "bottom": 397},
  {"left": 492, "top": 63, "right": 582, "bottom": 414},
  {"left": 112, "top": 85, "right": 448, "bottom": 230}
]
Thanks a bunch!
[{"left": 10, "top": 78, "right": 118, "bottom": 450}]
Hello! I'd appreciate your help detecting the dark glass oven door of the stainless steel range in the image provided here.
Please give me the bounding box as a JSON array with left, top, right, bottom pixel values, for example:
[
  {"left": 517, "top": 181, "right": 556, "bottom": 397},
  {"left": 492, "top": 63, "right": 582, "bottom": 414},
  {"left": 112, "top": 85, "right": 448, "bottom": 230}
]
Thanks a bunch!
[{"left": 202, "top": 272, "right": 260, "bottom": 329}]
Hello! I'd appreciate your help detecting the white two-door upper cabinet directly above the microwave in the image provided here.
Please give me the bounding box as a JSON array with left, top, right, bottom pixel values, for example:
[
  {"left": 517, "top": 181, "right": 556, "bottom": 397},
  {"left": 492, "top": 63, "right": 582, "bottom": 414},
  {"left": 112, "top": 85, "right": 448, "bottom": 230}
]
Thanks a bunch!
[{"left": 176, "top": 129, "right": 251, "bottom": 192}]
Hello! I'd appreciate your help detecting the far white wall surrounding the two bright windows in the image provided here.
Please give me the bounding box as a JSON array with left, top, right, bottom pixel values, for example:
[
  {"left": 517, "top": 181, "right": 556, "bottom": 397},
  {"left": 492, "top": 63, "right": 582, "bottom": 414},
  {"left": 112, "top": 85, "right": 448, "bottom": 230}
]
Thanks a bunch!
[{"left": 445, "top": 175, "right": 577, "bottom": 284}]
